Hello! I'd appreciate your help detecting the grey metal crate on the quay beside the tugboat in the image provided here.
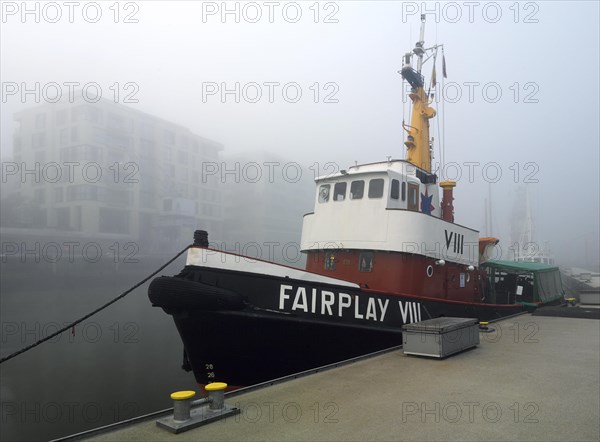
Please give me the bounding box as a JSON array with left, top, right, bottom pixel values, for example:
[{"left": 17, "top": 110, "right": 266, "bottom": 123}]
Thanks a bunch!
[{"left": 402, "top": 318, "right": 479, "bottom": 358}]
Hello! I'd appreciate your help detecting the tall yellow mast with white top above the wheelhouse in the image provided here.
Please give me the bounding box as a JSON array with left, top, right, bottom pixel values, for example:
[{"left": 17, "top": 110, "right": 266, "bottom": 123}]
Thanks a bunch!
[{"left": 400, "top": 14, "right": 439, "bottom": 173}]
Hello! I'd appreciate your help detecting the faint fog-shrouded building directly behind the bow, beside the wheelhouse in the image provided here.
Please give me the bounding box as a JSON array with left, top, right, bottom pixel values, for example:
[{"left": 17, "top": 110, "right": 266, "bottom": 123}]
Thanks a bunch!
[{"left": 220, "top": 152, "right": 315, "bottom": 267}]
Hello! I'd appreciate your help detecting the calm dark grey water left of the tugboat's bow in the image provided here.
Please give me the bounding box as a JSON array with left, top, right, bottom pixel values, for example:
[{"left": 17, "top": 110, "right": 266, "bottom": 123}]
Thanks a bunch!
[{"left": 0, "top": 259, "right": 197, "bottom": 440}]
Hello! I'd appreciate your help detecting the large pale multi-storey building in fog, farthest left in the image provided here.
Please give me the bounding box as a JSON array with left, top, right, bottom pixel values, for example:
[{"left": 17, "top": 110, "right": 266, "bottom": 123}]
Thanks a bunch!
[{"left": 3, "top": 99, "right": 223, "bottom": 251}]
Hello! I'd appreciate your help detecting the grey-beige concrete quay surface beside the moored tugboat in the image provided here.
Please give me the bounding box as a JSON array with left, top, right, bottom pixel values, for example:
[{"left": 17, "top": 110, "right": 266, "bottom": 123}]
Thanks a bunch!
[{"left": 72, "top": 314, "right": 600, "bottom": 441}]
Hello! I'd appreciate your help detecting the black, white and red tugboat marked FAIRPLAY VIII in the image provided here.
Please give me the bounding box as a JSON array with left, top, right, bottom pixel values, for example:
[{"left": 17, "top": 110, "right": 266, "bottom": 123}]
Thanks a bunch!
[{"left": 148, "top": 16, "right": 564, "bottom": 386}]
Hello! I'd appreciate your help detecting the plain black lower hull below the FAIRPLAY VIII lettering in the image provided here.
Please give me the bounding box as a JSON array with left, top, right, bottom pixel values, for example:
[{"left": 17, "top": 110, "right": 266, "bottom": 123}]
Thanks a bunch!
[{"left": 174, "top": 312, "right": 402, "bottom": 386}]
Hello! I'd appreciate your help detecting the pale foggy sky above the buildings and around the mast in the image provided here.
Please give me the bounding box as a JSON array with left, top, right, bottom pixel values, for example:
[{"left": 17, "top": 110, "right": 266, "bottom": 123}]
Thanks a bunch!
[{"left": 1, "top": 2, "right": 599, "bottom": 266}]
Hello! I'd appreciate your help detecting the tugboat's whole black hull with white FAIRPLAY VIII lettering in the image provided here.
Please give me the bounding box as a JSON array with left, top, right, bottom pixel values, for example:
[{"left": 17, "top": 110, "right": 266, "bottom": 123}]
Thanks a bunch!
[{"left": 149, "top": 266, "right": 525, "bottom": 386}]
